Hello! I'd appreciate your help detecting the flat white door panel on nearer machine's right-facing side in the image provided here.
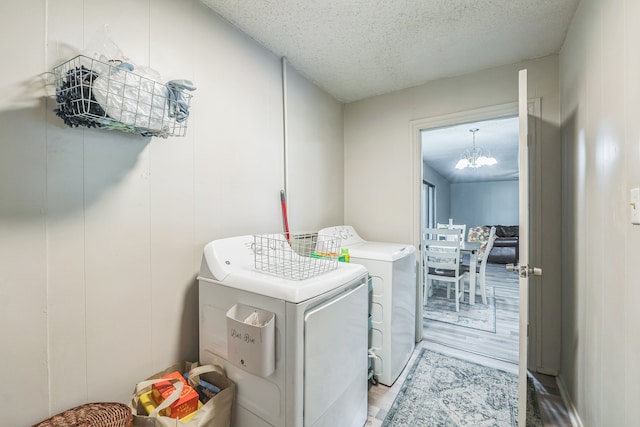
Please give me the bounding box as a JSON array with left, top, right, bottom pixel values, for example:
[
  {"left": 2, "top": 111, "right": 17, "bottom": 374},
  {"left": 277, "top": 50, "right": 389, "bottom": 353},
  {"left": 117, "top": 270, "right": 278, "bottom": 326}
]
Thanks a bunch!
[{"left": 304, "top": 282, "right": 369, "bottom": 427}]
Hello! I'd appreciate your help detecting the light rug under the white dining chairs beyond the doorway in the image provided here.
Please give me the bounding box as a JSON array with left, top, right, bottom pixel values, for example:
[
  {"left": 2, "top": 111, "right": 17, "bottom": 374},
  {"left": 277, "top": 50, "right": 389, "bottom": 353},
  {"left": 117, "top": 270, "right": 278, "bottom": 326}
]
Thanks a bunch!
[{"left": 423, "top": 286, "right": 496, "bottom": 333}]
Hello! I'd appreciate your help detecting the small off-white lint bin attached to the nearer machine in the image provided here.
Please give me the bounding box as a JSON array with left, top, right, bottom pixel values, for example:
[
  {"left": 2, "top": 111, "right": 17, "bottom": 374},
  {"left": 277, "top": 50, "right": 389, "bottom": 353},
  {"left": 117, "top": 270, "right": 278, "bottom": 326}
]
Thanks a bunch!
[{"left": 227, "top": 304, "right": 276, "bottom": 377}]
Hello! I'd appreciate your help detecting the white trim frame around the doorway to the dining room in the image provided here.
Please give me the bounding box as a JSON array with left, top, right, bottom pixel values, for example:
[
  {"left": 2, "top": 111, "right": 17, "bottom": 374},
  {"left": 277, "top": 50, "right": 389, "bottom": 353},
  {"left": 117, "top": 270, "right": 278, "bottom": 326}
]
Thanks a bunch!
[{"left": 409, "top": 98, "right": 542, "bottom": 372}]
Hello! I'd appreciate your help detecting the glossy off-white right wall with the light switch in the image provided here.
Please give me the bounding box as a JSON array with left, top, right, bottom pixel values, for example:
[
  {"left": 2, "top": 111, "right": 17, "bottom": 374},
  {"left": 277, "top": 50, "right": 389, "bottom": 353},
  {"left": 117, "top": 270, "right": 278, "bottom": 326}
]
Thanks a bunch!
[{"left": 560, "top": 0, "right": 640, "bottom": 426}]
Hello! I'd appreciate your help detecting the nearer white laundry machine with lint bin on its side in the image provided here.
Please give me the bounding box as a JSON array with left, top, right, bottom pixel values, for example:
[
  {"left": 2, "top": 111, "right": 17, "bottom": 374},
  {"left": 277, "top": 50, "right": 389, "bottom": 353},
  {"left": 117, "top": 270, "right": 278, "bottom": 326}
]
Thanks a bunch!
[{"left": 198, "top": 236, "right": 368, "bottom": 427}]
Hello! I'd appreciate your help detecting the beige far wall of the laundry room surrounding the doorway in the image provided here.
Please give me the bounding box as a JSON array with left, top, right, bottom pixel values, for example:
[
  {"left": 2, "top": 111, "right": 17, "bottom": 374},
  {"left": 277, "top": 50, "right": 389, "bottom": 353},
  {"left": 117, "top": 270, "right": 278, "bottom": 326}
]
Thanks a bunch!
[{"left": 344, "top": 55, "right": 562, "bottom": 372}]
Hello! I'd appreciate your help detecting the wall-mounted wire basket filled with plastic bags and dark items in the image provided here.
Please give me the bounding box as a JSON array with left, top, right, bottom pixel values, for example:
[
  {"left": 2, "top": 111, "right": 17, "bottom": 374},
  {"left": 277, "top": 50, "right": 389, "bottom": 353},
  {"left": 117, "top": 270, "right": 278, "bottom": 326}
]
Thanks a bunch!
[{"left": 53, "top": 55, "right": 195, "bottom": 138}]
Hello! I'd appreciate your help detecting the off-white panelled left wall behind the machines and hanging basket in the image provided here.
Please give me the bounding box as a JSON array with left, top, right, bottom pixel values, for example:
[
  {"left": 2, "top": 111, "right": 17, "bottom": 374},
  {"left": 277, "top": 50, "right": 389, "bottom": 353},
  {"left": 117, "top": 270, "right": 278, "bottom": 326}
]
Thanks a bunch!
[{"left": 0, "top": 0, "right": 343, "bottom": 426}]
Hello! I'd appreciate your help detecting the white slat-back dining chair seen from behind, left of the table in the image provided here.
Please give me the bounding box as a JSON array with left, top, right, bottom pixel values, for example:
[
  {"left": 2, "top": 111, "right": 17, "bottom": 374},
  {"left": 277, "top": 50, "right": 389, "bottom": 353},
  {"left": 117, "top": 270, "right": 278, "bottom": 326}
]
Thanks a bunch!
[{"left": 423, "top": 228, "right": 465, "bottom": 311}]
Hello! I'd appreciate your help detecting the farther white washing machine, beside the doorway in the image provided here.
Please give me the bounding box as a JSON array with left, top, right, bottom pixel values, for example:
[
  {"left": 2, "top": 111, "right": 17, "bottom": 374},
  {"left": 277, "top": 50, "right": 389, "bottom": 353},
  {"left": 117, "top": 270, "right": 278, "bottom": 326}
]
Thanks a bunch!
[{"left": 318, "top": 225, "right": 417, "bottom": 386}]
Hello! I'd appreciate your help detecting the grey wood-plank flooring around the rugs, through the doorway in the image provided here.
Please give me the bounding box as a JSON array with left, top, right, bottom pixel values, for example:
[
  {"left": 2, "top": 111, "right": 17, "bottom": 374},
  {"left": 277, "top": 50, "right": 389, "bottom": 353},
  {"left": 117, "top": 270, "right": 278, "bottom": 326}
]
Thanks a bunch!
[{"left": 366, "top": 264, "right": 572, "bottom": 427}]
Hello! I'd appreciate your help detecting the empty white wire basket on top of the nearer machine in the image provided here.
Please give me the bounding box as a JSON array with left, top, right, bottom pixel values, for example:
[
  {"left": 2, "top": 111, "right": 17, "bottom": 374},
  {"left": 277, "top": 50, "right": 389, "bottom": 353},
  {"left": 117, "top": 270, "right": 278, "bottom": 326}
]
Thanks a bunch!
[{"left": 253, "top": 234, "right": 341, "bottom": 280}]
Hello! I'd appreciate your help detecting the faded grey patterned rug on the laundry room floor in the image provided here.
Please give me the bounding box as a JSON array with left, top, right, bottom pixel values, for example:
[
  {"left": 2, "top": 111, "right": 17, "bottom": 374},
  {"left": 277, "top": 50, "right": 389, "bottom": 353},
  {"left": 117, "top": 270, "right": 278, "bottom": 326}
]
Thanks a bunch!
[{"left": 382, "top": 349, "right": 542, "bottom": 427}]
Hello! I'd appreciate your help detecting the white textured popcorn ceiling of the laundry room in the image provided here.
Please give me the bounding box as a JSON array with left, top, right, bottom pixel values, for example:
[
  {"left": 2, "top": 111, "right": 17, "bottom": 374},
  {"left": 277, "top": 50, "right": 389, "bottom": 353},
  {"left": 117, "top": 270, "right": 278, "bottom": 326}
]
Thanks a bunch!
[{"left": 202, "top": 0, "right": 579, "bottom": 102}]
